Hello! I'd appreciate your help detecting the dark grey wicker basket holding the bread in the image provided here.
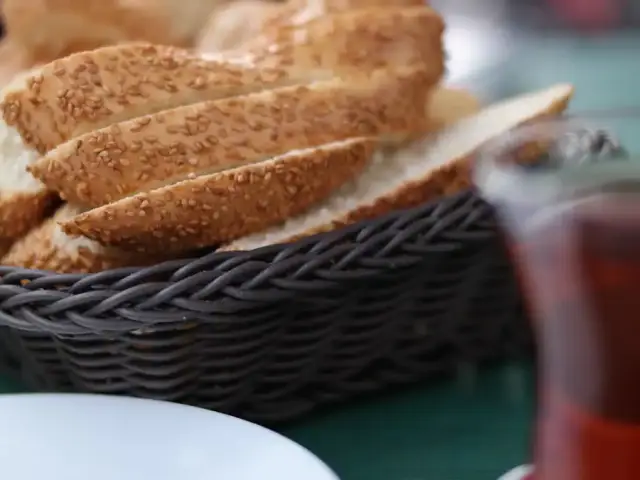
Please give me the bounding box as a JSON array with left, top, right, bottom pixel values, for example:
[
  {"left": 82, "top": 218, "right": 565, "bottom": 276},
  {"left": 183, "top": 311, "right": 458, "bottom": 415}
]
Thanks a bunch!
[{"left": 0, "top": 192, "right": 530, "bottom": 423}]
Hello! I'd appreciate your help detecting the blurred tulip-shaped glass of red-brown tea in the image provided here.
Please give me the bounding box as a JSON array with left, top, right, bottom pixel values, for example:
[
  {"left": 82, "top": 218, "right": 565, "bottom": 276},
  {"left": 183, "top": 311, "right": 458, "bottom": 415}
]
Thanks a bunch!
[{"left": 475, "top": 119, "right": 640, "bottom": 480}]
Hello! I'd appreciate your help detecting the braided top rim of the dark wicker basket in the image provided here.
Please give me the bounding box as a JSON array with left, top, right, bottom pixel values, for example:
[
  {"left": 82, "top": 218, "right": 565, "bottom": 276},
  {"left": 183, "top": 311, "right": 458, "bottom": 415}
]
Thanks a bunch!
[{"left": 0, "top": 190, "right": 495, "bottom": 335}]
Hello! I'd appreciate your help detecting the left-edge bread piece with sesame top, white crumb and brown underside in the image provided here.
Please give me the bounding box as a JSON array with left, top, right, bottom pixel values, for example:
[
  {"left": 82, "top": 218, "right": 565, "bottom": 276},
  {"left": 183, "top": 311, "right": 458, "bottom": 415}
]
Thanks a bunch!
[{"left": 0, "top": 44, "right": 295, "bottom": 240}]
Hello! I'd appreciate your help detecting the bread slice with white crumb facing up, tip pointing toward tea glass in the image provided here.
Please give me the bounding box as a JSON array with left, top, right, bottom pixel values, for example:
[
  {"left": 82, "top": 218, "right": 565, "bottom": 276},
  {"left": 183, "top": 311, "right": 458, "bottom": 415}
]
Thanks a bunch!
[{"left": 222, "top": 84, "right": 573, "bottom": 250}]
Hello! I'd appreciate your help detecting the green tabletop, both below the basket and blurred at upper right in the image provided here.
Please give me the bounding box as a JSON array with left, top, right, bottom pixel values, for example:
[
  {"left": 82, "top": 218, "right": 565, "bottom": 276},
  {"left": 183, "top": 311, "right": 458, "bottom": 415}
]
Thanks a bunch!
[{"left": 0, "top": 20, "right": 640, "bottom": 480}]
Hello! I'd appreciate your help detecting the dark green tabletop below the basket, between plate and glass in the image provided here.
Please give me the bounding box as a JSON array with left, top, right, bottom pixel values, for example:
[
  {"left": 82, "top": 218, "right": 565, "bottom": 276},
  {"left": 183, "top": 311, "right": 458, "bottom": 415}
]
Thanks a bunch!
[{"left": 0, "top": 365, "right": 533, "bottom": 480}]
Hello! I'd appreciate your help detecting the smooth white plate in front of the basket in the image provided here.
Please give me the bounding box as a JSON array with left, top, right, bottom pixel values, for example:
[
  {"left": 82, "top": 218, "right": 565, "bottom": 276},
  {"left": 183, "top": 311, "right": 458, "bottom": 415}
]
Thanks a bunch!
[{"left": 0, "top": 394, "right": 338, "bottom": 480}]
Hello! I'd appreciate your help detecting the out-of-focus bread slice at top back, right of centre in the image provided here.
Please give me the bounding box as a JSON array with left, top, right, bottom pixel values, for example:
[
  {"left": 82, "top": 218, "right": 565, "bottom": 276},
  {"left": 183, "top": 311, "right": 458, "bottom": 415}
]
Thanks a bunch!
[{"left": 212, "top": 6, "right": 444, "bottom": 78}]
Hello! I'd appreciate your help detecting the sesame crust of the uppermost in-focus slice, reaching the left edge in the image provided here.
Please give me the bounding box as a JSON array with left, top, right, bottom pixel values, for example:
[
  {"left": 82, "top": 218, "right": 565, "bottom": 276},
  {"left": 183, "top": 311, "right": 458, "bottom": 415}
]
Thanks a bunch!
[{"left": 0, "top": 43, "right": 298, "bottom": 153}]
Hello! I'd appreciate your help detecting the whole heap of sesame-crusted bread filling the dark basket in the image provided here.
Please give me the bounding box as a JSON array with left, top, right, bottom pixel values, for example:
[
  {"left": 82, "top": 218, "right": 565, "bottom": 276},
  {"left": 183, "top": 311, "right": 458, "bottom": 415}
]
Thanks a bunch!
[{"left": 0, "top": 0, "right": 573, "bottom": 273}]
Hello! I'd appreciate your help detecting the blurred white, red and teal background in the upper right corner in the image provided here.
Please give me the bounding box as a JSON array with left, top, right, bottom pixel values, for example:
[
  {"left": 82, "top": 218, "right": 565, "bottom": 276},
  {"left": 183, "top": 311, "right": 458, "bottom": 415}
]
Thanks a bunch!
[{"left": 430, "top": 0, "right": 640, "bottom": 111}]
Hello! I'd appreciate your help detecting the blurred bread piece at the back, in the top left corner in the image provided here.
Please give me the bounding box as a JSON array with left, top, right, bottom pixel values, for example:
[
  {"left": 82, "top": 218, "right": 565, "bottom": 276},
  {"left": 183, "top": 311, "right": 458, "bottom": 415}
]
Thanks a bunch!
[{"left": 2, "top": 0, "right": 223, "bottom": 60}]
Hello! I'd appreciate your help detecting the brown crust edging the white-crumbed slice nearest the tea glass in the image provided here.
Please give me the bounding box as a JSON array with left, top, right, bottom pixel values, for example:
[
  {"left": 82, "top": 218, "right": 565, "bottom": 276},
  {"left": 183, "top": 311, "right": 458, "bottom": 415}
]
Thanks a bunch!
[{"left": 220, "top": 89, "right": 573, "bottom": 251}]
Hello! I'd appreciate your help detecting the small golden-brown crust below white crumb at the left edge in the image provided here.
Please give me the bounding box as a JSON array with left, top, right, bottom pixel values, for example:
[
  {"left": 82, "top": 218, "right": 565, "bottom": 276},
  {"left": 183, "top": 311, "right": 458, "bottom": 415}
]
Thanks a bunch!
[{"left": 0, "top": 190, "right": 57, "bottom": 243}]
